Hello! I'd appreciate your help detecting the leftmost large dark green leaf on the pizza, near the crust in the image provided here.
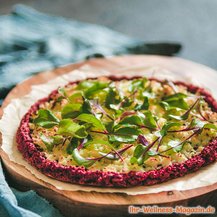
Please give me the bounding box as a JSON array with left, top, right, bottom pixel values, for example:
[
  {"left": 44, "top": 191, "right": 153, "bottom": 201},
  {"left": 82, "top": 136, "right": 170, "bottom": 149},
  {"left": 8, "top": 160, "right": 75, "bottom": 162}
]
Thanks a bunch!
[{"left": 33, "top": 109, "right": 59, "bottom": 128}]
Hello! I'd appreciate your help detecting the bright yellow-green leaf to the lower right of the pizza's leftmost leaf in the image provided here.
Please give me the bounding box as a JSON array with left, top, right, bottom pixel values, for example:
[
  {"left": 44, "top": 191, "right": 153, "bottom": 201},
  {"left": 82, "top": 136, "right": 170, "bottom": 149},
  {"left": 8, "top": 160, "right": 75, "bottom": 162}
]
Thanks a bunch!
[{"left": 57, "top": 119, "right": 88, "bottom": 138}]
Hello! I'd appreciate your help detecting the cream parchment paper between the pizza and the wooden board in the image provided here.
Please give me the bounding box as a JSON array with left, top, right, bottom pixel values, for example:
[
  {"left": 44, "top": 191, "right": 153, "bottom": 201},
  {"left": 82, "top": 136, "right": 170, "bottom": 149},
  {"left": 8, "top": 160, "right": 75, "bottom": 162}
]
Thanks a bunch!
[{"left": 0, "top": 65, "right": 217, "bottom": 195}]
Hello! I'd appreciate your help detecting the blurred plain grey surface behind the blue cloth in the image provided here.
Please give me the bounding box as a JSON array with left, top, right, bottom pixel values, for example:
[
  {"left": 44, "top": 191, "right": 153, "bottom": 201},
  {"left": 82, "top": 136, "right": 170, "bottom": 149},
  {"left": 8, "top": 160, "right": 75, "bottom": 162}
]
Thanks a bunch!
[{"left": 0, "top": 0, "right": 217, "bottom": 69}]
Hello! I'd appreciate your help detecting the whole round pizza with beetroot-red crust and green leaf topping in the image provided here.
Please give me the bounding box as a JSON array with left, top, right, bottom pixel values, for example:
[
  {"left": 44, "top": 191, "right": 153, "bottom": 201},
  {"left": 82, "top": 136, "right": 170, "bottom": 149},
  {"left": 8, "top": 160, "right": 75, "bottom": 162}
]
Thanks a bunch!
[{"left": 16, "top": 76, "right": 217, "bottom": 187}]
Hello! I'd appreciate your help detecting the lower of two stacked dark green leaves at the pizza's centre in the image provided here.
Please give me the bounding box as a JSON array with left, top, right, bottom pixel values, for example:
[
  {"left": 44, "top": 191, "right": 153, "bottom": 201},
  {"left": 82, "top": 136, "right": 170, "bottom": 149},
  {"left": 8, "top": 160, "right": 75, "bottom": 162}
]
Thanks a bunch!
[{"left": 109, "top": 127, "right": 141, "bottom": 143}]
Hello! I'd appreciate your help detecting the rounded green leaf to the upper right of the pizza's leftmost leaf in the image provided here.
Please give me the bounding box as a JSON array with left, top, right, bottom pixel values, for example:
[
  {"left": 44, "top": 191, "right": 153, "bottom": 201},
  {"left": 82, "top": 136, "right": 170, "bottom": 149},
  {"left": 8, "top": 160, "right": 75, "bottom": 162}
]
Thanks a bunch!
[{"left": 61, "top": 103, "right": 82, "bottom": 119}]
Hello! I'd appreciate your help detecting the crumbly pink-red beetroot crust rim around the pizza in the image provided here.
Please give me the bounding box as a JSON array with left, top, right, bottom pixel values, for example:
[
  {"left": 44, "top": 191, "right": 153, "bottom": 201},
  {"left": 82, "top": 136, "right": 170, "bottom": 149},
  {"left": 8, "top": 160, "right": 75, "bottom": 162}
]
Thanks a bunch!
[{"left": 16, "top": 76, "right": 217, "bottom": 187}]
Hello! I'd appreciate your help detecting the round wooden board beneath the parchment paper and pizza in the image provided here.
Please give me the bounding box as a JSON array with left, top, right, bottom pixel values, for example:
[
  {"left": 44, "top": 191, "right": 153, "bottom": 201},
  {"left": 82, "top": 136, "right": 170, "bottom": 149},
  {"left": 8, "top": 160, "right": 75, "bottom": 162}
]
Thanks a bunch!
[{"left": 0, "top": 55, "right": 217, "bottom": 216}]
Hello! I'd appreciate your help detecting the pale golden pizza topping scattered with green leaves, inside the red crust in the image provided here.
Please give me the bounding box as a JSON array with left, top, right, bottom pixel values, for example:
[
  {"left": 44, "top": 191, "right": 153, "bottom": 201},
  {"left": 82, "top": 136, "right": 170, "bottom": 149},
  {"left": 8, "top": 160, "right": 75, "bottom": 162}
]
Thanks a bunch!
[{"left": 30, "top": 78, "right": 217, "bottom": 172}]
